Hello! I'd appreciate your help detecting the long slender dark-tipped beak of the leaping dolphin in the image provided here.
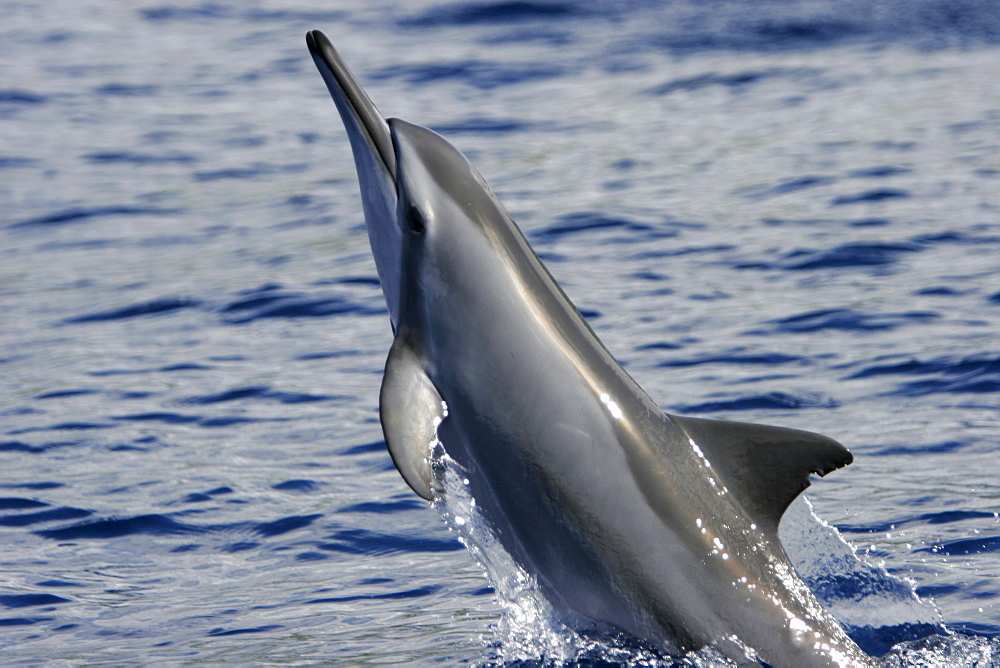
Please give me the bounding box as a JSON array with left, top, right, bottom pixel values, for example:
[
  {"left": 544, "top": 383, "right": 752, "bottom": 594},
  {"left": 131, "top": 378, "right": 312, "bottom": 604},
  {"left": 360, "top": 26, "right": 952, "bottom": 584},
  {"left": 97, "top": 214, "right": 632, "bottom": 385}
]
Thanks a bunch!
[{"left": 306, "top": 30, "right": 396, "bottom": 179}]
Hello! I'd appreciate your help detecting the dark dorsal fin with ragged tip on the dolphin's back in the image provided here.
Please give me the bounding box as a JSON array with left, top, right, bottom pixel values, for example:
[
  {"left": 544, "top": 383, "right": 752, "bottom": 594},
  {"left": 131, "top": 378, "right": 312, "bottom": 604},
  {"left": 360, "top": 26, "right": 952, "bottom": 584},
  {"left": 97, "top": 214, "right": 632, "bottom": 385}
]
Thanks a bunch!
[{"left": 668, "top": 415, "right": 854, "bottom": 535}]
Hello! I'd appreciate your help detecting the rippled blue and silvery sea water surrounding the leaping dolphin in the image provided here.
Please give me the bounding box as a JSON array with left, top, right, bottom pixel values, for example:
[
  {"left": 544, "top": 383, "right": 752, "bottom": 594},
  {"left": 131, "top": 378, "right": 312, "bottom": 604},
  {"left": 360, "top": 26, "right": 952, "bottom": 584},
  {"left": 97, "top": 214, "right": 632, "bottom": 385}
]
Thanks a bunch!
[{"left": 0, "top": 0, "right": 1000, "bottom": 666}]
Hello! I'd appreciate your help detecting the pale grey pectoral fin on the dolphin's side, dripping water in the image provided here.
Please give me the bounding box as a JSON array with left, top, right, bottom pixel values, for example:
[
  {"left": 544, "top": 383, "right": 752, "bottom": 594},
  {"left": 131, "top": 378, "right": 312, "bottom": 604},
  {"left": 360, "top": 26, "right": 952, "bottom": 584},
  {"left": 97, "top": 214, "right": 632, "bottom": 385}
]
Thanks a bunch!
[{"left": 379, "top": 336, "right": 447, "bottom": 501}]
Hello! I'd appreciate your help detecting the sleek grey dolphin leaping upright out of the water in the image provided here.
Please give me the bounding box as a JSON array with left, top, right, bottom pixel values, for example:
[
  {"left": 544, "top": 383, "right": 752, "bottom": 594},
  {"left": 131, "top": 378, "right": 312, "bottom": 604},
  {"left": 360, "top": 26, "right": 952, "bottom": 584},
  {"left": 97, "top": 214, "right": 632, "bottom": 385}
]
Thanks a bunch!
[{"left": 307, "top": 31, "right": 872, "bottom": 668}]
